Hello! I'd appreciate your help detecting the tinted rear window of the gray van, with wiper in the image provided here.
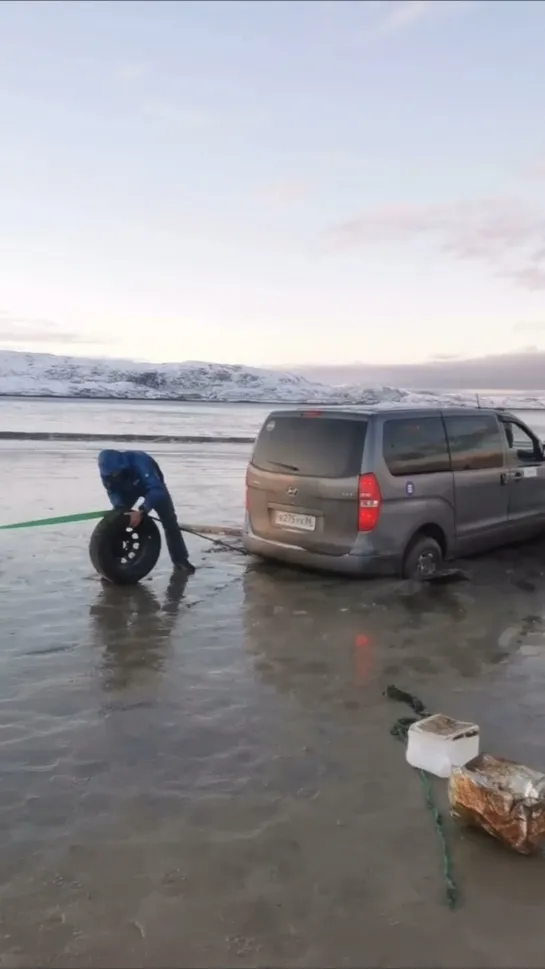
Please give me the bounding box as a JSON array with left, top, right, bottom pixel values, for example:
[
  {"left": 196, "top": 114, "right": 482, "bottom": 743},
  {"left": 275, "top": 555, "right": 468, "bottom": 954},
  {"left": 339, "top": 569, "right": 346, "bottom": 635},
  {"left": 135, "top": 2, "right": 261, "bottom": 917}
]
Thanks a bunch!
[{"left": 252, "top": 417, "right": 367, "bottom": 478}]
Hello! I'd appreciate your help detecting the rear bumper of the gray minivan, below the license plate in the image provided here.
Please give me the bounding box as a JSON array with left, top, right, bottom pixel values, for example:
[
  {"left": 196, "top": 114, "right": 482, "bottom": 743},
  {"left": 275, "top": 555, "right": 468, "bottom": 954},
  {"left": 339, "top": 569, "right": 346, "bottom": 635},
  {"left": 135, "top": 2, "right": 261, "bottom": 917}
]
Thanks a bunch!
[{"left": 242, "top": 523, "right": 401, "bottom": 577}]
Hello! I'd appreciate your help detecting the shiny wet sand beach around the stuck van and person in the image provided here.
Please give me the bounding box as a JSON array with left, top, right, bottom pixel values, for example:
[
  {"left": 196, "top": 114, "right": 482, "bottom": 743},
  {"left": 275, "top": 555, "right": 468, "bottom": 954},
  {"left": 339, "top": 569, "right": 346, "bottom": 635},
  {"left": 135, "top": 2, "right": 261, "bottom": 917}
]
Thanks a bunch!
[{"left": 0, "top": 428, "right": 545, "bottom": 969}]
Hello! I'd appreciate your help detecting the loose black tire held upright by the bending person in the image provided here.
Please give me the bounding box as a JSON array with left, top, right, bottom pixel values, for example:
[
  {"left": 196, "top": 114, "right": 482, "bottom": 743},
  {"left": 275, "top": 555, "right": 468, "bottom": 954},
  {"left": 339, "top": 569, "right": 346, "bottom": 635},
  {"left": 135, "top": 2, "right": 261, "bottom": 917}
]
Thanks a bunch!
[{"left": 89, "top": 511, "right": 161, "bottom": 585}]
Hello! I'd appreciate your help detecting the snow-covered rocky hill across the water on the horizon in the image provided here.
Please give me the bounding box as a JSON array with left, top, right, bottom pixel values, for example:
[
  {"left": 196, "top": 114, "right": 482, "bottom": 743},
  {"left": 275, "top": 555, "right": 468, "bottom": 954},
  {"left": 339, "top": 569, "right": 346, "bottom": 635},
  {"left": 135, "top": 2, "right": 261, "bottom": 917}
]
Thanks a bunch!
[{"left": 0, "top": 350, "right": 543, "bottom": 407}]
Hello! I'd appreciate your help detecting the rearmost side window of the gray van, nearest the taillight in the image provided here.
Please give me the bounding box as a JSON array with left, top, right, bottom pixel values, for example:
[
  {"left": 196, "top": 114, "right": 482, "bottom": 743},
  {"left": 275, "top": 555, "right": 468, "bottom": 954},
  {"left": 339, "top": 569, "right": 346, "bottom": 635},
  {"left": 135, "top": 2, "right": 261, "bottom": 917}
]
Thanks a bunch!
[{"left": 382, "top": 417, "right": 450, "bottom": 477}]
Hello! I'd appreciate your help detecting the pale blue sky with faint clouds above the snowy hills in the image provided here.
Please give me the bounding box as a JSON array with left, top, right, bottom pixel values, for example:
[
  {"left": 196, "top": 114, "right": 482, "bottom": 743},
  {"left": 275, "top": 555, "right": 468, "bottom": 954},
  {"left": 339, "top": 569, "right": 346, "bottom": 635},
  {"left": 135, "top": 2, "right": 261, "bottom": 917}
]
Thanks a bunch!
[{"left": 0, "top": 0, "right": 545, "bottom": 366}]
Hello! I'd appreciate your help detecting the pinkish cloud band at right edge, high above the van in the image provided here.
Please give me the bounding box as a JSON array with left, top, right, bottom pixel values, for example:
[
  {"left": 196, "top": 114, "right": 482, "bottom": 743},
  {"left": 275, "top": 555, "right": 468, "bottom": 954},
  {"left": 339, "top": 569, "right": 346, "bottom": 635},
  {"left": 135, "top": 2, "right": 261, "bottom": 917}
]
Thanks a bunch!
[{"left": 325, "top": 198, "right": 545, "bottom": 290}]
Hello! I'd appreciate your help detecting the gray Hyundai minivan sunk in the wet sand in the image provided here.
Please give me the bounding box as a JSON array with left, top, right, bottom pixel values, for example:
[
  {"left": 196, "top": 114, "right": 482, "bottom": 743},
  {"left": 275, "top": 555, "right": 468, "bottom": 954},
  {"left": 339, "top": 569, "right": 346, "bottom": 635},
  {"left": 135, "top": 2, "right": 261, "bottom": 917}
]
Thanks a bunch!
[{"left": 243, "top": 407, "right": 545, "bottom": 577}]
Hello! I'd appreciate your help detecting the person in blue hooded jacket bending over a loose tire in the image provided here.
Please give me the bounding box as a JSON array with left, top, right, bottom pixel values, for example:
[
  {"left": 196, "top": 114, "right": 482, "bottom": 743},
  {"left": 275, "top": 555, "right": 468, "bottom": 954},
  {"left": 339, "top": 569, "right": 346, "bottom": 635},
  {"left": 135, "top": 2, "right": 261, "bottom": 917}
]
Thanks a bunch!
[{"left": 98, "top": 451, "right": 195, "bottom": 575}]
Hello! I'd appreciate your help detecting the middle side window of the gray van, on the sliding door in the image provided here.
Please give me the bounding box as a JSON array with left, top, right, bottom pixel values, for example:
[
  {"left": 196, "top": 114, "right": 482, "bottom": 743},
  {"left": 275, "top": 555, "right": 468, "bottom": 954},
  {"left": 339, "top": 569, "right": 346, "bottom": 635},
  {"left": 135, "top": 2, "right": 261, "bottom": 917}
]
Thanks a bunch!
[{"left": 445, "top": 414, "right": 505, "bottom": 471}]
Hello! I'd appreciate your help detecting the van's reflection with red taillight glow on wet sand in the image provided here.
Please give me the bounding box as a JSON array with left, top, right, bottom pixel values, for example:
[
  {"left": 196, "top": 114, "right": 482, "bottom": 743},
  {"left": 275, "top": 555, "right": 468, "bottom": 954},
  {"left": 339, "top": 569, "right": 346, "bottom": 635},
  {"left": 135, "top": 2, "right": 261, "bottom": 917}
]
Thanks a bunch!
[{"left": 240, "top": 563, "right": 520, "bottom": 703}]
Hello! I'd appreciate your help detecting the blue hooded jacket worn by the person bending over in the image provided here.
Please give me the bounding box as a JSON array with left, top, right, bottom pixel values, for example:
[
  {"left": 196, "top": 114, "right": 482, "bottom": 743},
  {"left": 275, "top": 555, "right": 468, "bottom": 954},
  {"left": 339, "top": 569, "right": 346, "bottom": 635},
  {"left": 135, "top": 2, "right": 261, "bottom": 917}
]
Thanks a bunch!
[{"left": 98, "top": 451, "right": 169, "bottom": 512}]
